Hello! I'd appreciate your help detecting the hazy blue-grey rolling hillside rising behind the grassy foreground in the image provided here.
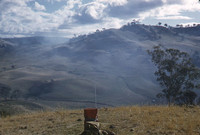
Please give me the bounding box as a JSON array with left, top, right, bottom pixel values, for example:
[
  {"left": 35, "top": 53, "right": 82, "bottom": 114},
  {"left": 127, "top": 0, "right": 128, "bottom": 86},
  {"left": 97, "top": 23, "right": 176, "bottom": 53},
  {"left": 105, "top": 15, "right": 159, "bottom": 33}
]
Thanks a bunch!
[{"left": 0, "top": 24, "right": 200, "bottom": 107}]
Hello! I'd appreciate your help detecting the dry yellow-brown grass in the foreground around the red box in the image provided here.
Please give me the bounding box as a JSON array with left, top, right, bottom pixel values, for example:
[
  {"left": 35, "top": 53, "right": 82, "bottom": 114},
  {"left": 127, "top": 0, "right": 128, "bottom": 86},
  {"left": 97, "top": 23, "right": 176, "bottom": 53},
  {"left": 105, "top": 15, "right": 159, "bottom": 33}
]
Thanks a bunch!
[{"left": 0, "top": 106, "right": 200, "bottom": 135}]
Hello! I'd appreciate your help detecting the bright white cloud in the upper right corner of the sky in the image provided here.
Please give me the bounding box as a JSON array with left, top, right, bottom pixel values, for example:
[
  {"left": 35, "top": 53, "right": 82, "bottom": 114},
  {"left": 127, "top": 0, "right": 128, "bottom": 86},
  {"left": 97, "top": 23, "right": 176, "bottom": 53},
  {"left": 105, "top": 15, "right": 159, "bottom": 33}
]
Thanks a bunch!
[{"left": 139, "top": 0, "right": 200, "bottom": 20}]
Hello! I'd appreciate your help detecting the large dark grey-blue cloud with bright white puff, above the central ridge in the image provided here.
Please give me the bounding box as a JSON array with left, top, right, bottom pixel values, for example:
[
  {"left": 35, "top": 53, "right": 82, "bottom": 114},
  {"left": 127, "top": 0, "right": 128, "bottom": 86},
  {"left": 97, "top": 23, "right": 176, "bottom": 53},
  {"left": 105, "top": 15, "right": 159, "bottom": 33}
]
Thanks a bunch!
[{"left": 66, "top": 0, "right": 164, "bottom": 24}]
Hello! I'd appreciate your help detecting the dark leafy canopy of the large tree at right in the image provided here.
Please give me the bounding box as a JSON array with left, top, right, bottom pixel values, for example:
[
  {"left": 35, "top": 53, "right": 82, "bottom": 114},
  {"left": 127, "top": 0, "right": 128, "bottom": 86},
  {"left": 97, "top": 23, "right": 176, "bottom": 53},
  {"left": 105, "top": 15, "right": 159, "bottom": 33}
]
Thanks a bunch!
[{"left": 148, "top": 45, "right": 200, "bottom": 105}]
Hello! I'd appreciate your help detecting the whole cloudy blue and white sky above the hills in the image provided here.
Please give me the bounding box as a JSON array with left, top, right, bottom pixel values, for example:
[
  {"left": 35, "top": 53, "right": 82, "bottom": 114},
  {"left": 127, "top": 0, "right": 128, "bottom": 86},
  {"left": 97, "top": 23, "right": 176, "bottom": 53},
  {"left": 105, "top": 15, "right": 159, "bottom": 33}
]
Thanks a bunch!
[{"left": 0, "top": 0, "right": 200, "bottom": 38}]
